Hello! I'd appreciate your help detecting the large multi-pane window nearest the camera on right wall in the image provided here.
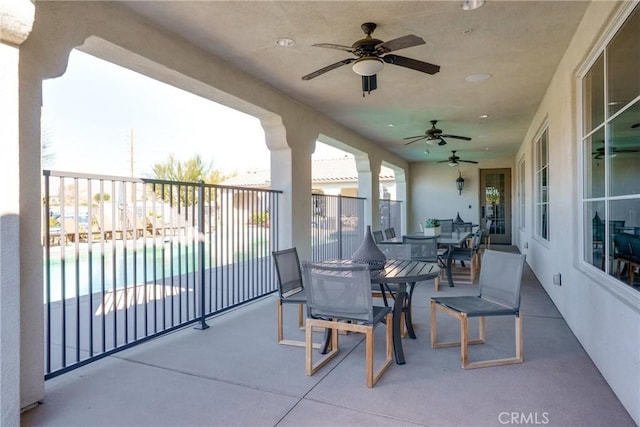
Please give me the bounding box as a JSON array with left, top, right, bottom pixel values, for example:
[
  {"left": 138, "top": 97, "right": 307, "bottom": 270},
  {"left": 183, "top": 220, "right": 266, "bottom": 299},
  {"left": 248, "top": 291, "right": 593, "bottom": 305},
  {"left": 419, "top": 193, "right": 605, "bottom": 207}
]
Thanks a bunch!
[{"left": 581, "top": 2, "right": 640, "bottom": 289}]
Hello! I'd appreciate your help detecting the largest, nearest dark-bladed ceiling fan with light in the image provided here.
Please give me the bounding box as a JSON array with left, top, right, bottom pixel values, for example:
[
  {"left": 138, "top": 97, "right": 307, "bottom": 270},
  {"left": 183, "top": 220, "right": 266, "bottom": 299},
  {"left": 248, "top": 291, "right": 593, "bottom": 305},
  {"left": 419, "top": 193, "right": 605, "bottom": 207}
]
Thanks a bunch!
[{"left": 302, "top": 22, "right": 440, "bottom": 96}]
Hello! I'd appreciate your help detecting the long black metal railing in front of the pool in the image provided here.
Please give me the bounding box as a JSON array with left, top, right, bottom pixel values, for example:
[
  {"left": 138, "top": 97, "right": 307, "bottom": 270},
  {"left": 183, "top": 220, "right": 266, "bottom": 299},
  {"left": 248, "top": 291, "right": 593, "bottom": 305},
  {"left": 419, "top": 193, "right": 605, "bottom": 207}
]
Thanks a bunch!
[{"left": 42, "top": 171, "right": 280, "bottom": 379}]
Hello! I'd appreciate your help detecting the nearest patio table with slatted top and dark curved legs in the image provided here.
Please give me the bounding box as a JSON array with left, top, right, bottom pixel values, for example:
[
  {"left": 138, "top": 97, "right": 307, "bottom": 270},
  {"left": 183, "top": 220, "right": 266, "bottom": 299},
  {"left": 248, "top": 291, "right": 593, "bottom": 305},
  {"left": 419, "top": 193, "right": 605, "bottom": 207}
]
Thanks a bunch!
[{"left": 320, "top": 259, "right": 440, "bottom": 365}]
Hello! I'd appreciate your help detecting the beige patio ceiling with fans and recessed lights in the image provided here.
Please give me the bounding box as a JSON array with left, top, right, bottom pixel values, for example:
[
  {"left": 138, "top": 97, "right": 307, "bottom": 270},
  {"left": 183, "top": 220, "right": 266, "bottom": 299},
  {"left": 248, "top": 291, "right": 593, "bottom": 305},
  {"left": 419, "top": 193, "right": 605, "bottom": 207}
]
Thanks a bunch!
[{"left": 124, "top": 1, "right": 589, "bottom": 161}]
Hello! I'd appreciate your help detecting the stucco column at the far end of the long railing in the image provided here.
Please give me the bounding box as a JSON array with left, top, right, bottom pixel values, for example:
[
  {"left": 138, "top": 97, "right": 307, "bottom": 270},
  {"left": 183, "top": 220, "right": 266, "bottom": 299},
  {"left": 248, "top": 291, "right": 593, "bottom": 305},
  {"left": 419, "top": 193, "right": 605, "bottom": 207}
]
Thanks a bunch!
[{"left": 262, "top": 117, "right": 318, "bottom": 260}]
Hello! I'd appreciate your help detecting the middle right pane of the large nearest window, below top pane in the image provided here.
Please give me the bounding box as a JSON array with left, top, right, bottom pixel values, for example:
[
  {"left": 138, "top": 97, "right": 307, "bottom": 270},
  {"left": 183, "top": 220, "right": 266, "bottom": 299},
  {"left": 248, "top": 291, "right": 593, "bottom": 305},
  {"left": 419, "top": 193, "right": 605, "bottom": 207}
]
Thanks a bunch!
[{"left": 607, "top": 102, "right": 640, "bottom": 196}]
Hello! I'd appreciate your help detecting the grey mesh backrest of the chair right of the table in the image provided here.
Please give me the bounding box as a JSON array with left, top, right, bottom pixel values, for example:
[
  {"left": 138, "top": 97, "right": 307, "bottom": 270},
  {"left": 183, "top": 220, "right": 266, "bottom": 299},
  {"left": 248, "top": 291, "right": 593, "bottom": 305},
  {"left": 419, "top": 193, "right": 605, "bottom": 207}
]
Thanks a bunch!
[{"left": 479, "top": 250, "right": 526, "bottom": 310}]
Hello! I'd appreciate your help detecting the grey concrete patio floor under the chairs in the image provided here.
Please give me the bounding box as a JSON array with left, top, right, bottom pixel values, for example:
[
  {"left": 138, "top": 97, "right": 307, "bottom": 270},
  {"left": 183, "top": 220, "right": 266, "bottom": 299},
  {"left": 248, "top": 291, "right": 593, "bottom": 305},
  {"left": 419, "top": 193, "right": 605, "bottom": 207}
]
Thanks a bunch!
[{"left": 22, "top": 247, "right": 635, "bottom": 427}]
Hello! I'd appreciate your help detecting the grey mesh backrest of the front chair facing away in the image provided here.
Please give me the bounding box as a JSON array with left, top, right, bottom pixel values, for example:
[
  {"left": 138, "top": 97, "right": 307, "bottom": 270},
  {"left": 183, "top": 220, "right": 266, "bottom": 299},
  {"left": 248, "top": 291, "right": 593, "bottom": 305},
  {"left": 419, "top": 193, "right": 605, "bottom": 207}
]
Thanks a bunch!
[{"left": 303, "top": 263, "right": 373, "bottom": 324}]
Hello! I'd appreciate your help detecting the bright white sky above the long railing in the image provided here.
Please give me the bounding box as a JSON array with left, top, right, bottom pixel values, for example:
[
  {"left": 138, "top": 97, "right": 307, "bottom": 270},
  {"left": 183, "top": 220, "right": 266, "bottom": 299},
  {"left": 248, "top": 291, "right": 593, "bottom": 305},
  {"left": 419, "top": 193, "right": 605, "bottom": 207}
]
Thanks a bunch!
[{"left": 42, "top": 50, "right": 337, "bottom": 177}]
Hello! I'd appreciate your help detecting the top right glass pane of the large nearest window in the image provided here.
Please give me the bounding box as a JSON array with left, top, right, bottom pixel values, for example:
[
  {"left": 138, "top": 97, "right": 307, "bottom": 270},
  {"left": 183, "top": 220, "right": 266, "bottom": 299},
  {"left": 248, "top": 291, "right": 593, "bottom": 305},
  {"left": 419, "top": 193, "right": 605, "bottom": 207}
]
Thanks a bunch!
[{"left": 607, "top": 8, "right": 640, "bottom": 117}]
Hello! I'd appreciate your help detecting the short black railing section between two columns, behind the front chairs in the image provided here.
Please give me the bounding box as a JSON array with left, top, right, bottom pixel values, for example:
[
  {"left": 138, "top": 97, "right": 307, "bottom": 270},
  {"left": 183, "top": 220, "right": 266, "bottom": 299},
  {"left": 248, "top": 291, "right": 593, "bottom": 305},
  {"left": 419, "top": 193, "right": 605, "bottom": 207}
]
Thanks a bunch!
[{"left": 311, "top": 194, "right": 365, "bottom": 261}]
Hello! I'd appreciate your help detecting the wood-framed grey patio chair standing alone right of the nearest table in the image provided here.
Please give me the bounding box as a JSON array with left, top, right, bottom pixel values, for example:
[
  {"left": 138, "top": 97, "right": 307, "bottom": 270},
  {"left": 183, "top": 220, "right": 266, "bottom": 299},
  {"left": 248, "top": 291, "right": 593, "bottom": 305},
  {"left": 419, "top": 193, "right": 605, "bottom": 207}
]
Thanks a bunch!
[{"left": 431, "top": 250, "right": 526, "bottom": 369}]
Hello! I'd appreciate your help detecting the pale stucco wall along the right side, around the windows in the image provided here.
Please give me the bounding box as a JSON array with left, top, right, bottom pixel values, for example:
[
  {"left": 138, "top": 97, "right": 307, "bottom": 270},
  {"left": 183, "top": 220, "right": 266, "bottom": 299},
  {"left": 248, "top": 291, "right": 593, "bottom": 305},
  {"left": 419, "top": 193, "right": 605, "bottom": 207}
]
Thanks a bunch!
[{"left": 516, "top": 2, "right": 640, "bottom": 423}]
